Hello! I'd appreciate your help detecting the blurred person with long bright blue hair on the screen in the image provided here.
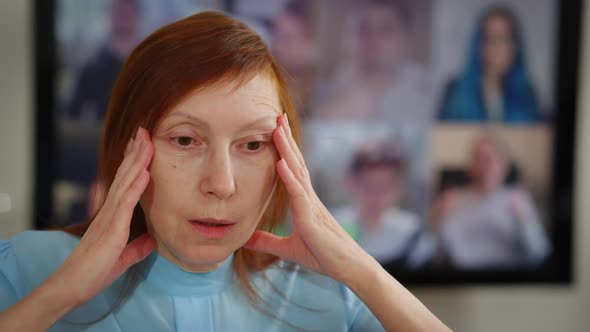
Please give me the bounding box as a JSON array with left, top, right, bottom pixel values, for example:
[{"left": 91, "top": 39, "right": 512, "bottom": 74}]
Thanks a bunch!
[{"left": 438, "top": 7, "right": 541, "bottom": 124}]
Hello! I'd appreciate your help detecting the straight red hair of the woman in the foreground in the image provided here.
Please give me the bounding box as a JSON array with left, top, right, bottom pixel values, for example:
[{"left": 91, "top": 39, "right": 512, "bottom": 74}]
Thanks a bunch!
[{"left": 66, "top": 12, "right": 300, "bottom": 306}]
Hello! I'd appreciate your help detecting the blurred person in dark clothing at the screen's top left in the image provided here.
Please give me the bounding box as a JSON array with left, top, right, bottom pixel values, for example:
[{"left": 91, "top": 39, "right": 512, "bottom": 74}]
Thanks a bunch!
[{"left": 67, "top": 0, "right": 140, "bottom": 121}]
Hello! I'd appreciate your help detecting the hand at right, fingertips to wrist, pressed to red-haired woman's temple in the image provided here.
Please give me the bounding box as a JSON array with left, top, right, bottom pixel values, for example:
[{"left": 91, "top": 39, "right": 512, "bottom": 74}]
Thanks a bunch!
[{"left": 245, "top": 115, "right": 373, "bottom": 283}]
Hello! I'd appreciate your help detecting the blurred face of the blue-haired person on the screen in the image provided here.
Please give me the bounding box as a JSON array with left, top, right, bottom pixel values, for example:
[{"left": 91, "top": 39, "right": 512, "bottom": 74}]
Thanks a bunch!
[{"left": 482, "top": 15, "right": 515, "bottom": 76}]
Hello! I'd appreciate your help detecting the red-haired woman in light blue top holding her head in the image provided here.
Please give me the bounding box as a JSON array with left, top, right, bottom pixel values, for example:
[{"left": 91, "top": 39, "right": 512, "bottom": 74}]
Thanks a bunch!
[{"left": 0, "top": 12, "right": 447, "bottom": 331}]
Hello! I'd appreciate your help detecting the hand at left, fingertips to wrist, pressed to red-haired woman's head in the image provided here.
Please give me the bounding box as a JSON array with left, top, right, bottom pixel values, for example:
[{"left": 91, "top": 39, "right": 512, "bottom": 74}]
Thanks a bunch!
[{"left": 46, "top": 127, "right": 156, "bottom": 307}]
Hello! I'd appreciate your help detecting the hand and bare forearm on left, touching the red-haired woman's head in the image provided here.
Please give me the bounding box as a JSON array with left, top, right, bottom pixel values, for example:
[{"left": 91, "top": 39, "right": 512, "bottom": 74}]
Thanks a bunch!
[{"left": 0, "top": 128, "right": 156, "bottom": 331}]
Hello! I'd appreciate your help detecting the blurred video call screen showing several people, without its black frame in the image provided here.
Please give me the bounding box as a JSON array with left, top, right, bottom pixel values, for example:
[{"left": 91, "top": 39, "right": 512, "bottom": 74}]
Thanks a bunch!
[{"left": 52, "top": 0, "right": 559, "bottom": 271}]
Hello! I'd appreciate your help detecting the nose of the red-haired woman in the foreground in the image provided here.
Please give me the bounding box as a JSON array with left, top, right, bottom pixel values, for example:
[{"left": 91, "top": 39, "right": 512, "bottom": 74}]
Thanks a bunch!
[{"left": 201, "top": 151, "right": 236, "bottom": 200}]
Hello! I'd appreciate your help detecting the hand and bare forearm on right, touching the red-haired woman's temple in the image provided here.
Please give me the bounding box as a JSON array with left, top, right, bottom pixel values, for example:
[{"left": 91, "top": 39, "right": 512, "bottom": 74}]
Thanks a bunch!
[{"left": 245, "top": 115, "right": 450, "bottom": 331}]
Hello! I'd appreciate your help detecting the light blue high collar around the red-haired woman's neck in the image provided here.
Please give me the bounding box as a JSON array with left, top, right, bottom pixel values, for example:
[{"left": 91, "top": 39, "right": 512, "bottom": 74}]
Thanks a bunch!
[{"left": 140, "top": 252, "right": 234, "bottom": 297}]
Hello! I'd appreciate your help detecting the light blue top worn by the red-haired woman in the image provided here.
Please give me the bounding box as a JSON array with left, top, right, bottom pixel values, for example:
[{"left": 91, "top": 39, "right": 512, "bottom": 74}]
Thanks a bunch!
[{"left": 0, "top": 231, "right": 383, "bottom": 332}]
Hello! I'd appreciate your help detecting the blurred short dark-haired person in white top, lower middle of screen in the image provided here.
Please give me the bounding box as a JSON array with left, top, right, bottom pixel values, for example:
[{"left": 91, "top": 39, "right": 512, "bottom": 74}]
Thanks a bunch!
[{"left": 333, "top": 144, "right": 421, "bottom": 267}]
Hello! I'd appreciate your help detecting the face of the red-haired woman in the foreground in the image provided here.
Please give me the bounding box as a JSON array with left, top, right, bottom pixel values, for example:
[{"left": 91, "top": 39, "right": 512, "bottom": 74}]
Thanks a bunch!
[{"left": 141, "top": 75, "right": 280, "bottom": 271}]
